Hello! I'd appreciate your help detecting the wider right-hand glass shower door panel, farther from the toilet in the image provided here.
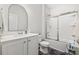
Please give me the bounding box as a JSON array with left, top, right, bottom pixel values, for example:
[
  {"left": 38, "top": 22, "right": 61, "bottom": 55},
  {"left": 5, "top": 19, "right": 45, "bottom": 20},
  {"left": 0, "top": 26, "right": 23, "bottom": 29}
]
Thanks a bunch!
[{"left": 59, "top": 14, "right": 75, "bottom": 42}]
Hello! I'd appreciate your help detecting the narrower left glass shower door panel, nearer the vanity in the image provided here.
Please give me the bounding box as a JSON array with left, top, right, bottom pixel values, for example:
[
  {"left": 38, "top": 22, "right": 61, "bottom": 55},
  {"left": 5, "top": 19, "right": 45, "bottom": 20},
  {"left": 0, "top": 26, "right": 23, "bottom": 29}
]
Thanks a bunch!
[{"left": 47, "top": 17, "right": 57, "bottom": 40}]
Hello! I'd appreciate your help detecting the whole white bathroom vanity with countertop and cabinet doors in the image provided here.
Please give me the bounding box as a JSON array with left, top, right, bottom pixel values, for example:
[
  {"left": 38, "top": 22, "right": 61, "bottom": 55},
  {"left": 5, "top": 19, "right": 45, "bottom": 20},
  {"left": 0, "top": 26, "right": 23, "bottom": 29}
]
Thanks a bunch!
[{"left": 0, "top": 33, "right": 39, "bottom": 55}]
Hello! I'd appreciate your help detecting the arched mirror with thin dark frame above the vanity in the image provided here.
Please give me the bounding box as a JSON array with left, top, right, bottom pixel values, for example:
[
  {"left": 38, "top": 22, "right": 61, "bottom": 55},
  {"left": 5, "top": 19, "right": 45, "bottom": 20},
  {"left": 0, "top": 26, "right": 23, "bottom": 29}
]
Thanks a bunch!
[{"left": 8, "top": 4, "right": 28, "bottom": 31}]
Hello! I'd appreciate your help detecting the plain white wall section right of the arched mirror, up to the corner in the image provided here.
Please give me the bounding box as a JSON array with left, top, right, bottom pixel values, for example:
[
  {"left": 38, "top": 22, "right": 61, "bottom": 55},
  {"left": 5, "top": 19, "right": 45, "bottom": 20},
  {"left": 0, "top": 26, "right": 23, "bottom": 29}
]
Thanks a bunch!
[{"left": 23, "top": 4, "right": 42, "bottom": 33}]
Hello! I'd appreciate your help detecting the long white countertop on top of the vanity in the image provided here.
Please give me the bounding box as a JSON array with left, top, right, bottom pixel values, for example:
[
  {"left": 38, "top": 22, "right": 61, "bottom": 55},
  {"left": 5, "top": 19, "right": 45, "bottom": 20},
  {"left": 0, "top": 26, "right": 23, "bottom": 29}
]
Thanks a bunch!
[{"left": 0, "top": 33, "right": 38, "bottom": 42}]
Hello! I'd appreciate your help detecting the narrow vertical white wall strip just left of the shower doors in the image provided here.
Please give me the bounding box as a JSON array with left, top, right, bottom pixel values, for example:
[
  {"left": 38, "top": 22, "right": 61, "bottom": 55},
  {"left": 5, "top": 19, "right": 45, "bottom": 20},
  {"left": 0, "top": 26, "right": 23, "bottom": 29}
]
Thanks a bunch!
[{"left": 42, "top": 5, "right": 50, "bottom": 39}]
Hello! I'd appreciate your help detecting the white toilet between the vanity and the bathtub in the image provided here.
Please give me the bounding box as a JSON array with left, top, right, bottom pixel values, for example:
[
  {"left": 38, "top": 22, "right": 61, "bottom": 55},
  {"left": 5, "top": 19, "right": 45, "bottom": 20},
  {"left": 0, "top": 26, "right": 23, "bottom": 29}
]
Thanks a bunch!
[{"left": 40, "top": 41, "right": 49, "bottom": 54}]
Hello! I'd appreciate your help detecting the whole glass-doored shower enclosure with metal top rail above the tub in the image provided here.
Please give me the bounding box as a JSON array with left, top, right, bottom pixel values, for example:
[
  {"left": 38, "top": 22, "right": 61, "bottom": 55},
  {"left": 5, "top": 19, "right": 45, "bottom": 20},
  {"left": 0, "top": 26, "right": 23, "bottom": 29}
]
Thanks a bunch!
[{"left": 46, "top": 11, "right": 78, "bottom": 42}]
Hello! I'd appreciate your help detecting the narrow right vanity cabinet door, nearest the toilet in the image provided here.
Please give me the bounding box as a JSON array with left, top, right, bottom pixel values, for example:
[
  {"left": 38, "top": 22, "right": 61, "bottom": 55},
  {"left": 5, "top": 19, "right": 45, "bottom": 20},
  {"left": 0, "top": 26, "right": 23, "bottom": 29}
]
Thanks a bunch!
[{"left": 28, "top": 36, "right": 38, "bottom": 55}]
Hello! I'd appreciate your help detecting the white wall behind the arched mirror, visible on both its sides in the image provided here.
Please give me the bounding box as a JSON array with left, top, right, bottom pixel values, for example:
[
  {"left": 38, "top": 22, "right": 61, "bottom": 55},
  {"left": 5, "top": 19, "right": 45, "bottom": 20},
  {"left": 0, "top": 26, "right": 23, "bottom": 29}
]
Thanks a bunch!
[{"left": 0, "top": 4, "right": 42, "bottom": 33}]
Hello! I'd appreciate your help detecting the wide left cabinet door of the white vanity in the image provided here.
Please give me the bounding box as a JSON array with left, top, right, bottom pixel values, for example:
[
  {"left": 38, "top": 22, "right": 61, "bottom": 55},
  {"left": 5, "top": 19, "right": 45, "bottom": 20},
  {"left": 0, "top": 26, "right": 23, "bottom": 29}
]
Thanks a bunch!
[{"left": 2, "top": 40, "right": 24, "bottom": 55}]
